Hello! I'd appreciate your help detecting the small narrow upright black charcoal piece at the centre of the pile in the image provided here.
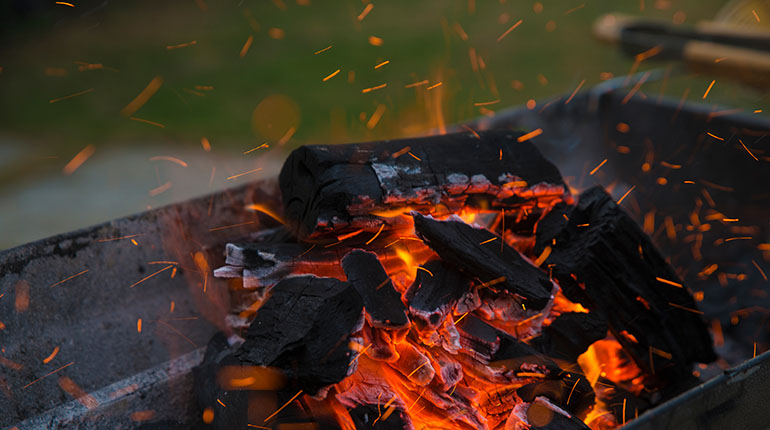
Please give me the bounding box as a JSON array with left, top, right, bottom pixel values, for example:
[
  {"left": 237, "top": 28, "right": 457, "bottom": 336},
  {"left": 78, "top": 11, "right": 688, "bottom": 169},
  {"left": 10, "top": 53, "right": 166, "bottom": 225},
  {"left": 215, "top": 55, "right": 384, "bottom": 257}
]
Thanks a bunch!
[{"left": 342, "top": 249, "right": 409, "bottom": 329}]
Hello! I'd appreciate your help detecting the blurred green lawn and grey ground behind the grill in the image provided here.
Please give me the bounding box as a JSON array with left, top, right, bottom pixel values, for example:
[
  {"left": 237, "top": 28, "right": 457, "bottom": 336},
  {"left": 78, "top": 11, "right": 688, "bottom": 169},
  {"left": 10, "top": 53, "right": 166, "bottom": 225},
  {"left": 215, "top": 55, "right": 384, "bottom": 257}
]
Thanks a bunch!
[{"left": 0, "top": 0, "right": 770, "bottom": 249}]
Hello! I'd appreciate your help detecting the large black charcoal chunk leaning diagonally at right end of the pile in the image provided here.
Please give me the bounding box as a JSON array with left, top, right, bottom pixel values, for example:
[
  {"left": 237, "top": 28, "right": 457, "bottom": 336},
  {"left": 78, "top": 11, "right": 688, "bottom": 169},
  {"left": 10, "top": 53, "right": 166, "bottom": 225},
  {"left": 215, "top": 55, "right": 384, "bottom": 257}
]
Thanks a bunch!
[{"left": 535, "top": 187, "right": 715, "bottom": 388}]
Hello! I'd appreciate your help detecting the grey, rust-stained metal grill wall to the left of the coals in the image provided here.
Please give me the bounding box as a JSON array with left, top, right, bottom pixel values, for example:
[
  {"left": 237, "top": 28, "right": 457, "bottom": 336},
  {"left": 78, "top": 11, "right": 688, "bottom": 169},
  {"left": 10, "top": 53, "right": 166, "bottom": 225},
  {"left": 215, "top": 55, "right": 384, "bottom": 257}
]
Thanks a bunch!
[{"left": 0, "top": 181, "right": 277, "bottom": 428}]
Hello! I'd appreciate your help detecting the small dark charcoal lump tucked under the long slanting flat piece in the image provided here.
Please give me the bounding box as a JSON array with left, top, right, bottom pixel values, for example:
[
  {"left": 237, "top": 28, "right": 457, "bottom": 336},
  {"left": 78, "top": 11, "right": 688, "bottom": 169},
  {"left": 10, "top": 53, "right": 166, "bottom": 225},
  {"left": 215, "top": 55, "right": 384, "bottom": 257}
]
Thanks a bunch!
[{"left": 406, "top": 260, "right": 472, "bottom": 330}]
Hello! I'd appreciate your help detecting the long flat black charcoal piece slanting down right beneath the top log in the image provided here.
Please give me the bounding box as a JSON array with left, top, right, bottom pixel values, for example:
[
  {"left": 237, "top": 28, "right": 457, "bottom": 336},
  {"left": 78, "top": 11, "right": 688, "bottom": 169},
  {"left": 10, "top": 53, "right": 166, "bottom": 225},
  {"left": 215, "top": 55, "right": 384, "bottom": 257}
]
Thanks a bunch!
[{"left": 414, "top": 213, "right": 553, "bottom": 309}]
